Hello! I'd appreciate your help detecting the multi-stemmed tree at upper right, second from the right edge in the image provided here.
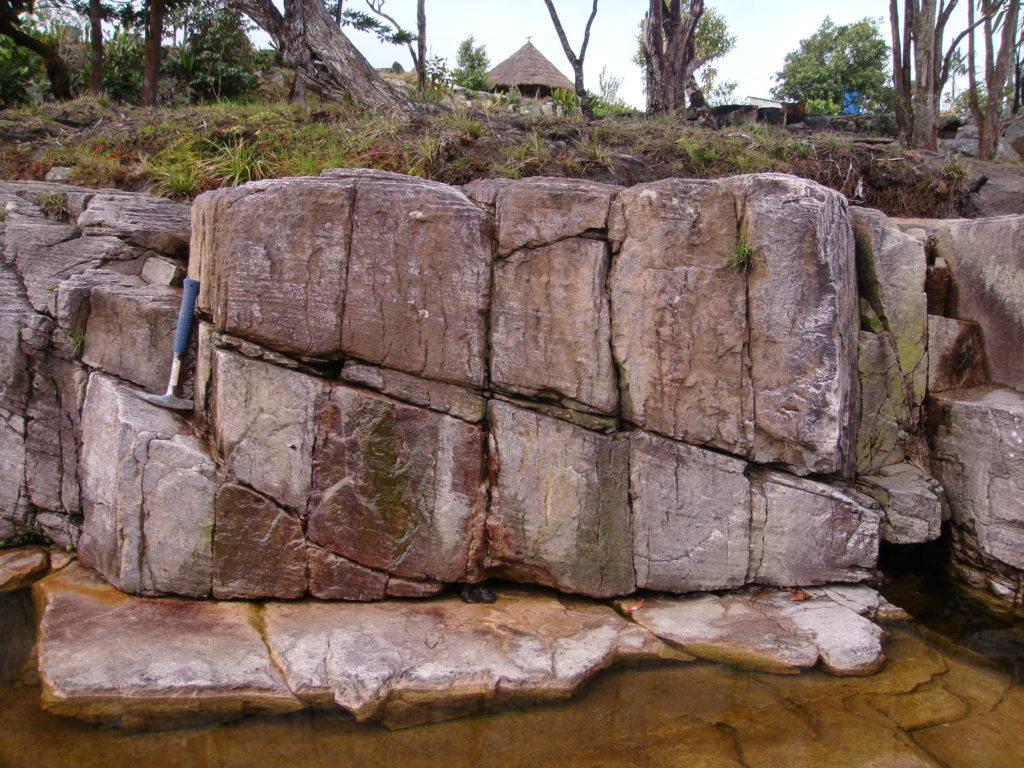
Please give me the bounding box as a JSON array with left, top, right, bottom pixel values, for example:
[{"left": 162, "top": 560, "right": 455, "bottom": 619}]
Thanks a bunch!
[{"left": 889, "top": 0, "right": 974, "bottom": 150}]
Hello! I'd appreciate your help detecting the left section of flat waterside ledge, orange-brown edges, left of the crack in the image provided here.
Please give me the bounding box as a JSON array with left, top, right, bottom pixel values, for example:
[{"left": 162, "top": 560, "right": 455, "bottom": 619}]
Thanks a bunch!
[{"left": 35, "top": 565, "right": 302, "bottom": 728}]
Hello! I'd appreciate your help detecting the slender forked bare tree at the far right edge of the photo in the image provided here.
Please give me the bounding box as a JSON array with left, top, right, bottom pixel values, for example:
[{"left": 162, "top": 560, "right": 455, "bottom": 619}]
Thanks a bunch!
[{"left": 967, "top": 0, "right": 1021, "bottom": 160}]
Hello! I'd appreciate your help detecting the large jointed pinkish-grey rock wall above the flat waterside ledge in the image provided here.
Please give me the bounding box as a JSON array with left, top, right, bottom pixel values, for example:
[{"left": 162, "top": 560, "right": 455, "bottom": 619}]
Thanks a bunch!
[{"left": 0, "top": 170, "right": 1012, "bottom": 600}]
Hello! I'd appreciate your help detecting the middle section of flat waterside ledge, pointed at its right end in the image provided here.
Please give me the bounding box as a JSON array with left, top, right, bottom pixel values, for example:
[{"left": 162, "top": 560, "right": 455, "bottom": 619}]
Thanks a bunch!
[{"left": 265, "top": 590, "right": 678, "bottom": 728}]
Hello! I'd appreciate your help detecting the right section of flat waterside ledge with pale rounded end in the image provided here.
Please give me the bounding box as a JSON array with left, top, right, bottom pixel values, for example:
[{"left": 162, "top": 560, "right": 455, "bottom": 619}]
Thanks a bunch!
[{"left": 632, "top": 588, "right": 885, "bottom": 675}]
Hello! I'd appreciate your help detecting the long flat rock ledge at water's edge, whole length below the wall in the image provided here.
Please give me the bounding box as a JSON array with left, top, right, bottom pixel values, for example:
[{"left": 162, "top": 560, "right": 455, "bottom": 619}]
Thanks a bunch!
[{"left": 34, "top": 565, "right": 899, "bottom": 728}]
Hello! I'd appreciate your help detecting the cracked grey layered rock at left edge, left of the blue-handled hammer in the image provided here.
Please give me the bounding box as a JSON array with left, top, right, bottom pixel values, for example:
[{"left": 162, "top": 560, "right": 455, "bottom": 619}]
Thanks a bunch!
[{"left": 0, "top": 182, "right": 190, "bottom": 557}]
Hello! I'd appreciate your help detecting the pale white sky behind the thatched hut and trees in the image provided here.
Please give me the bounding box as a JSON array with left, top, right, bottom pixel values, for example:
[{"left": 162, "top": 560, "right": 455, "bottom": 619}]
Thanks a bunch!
[{"left": 319, "top": 0, "right": 966, "bottom": 108}]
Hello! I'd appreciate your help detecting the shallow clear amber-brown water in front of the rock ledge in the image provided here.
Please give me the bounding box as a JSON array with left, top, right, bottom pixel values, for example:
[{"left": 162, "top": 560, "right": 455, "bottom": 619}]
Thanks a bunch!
[{"left": 0, "top": 624, "right": 1024, "bottom": 768}]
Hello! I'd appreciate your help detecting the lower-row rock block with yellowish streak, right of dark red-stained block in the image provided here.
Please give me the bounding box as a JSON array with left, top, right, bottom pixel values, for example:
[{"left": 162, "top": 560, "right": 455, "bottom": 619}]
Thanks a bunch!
[{"left": 485, "top": 400, "right": 636, "bottom": 597}]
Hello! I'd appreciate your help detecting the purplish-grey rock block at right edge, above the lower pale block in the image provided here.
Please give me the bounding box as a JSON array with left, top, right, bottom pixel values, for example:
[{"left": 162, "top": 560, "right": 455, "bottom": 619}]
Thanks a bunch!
[{"left": 935, "top": 216, "right": 1024, "bottom": 390}]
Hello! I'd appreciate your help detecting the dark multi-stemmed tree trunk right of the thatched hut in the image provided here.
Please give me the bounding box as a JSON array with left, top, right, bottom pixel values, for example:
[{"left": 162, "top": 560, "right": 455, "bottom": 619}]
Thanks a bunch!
[{"left": 641, "top": 0, "right": 710, "bottom": 114}]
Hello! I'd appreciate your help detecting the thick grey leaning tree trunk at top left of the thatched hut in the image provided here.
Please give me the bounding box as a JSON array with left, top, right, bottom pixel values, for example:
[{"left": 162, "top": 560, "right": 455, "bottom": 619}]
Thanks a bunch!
[{"left": 228, "top": 0, "right": 412, "bottom": 111}]
